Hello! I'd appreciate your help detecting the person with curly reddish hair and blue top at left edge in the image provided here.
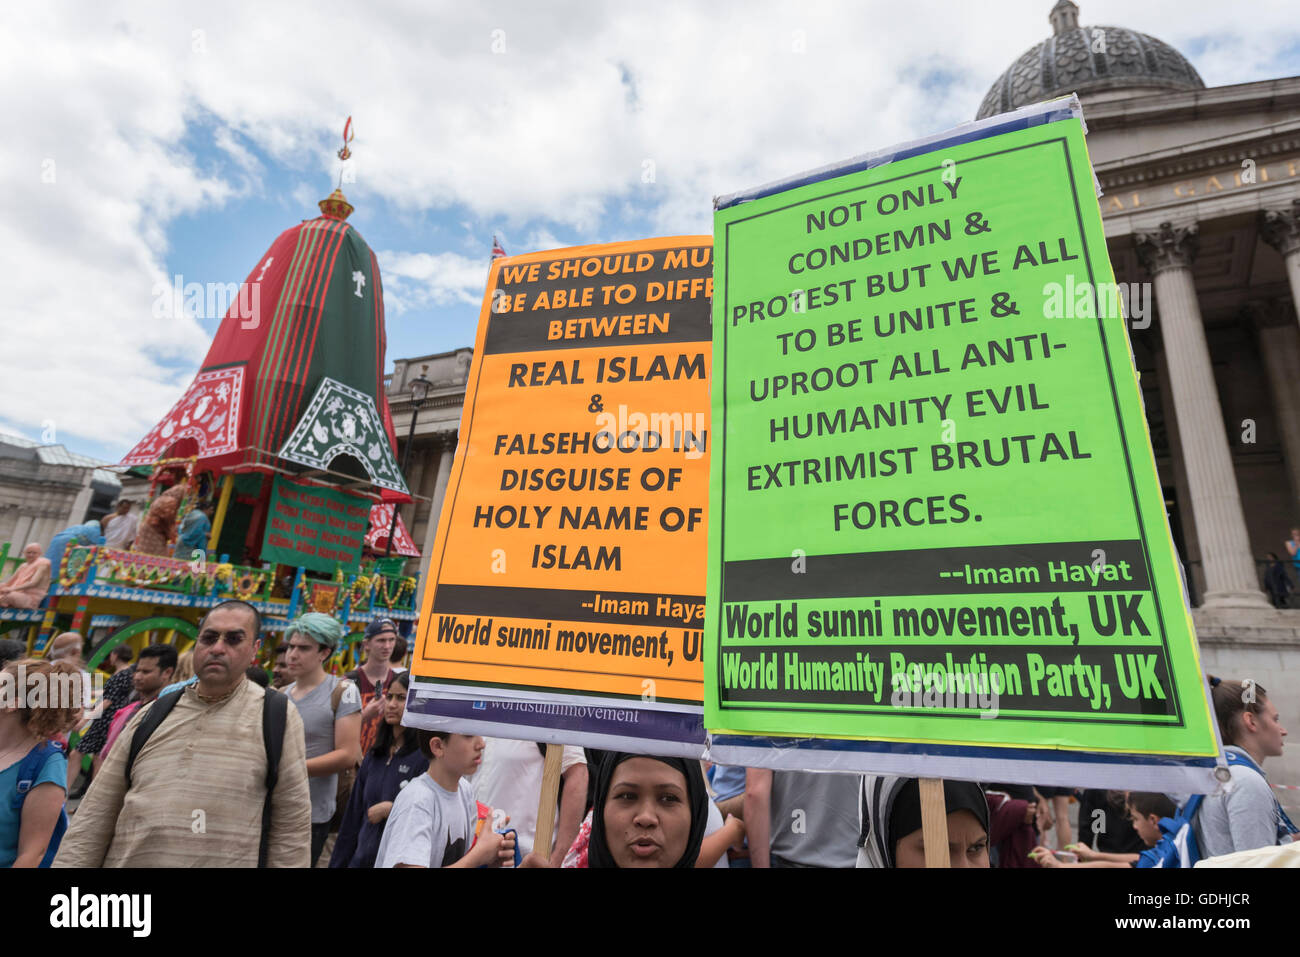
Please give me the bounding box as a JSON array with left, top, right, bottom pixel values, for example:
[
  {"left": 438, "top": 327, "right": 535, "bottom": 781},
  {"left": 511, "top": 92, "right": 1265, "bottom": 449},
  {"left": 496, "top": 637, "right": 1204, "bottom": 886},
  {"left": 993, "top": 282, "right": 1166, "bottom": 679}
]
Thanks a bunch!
[{"left": 0, "top": 658, "right": 81, "bottom": 867}]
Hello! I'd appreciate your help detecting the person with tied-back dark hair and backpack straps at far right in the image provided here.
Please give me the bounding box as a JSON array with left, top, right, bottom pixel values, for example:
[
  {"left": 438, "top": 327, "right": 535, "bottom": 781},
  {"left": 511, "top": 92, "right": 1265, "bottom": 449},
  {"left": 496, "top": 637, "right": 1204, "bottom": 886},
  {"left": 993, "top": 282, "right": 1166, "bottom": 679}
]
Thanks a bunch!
[{"left": 1188, "top": 675, "right": 1296, "bottom": 863}]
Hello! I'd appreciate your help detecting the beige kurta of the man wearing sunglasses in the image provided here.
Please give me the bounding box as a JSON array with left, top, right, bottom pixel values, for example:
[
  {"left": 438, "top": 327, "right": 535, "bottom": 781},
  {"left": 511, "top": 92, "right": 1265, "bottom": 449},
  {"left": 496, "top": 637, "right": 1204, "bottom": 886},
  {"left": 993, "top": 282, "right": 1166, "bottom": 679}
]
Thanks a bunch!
[{"left": 53, "top": 679, "right": 312, "bottom": 867}]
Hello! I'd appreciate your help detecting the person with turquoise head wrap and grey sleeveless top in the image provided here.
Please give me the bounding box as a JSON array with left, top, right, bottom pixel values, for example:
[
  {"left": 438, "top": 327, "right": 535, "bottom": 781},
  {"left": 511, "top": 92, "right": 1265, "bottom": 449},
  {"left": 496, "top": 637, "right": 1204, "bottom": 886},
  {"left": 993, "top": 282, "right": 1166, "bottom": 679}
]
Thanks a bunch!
[{"left": 285, "top": 611, "right": 361, "bottom": 867}]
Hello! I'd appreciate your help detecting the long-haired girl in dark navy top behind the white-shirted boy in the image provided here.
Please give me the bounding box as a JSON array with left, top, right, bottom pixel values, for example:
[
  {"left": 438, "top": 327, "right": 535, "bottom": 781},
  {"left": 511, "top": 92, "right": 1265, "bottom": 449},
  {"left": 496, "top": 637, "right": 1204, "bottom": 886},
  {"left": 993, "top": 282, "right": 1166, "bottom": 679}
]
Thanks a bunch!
[{"left": 329, "top": 674, "right": 429, "bottom": 867}]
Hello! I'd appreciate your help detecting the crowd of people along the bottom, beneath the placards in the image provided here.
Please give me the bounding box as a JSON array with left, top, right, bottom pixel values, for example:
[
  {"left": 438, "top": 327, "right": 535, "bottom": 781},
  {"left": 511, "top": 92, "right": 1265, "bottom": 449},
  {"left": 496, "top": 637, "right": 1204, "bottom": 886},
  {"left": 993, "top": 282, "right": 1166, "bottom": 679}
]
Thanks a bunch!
[{"left": 0, "top": 601, "right": 1296, "bottom": 869}]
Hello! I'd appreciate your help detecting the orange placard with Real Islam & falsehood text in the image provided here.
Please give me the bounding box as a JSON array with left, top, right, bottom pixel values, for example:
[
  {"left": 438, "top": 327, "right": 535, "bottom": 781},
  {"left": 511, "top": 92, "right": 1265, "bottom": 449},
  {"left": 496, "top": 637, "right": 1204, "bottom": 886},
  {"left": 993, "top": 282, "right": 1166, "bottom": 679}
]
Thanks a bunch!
[{"left": 412, "top": 237, "right": 712, "bottom": 706}]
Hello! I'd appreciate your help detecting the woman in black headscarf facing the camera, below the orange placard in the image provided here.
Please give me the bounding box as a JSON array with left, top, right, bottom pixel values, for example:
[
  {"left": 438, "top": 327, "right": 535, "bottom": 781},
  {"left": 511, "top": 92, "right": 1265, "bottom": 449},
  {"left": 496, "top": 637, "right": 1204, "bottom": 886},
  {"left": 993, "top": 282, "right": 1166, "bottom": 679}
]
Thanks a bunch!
[{"left": 588, "top": 752, "right": 709, "bottom": 867}]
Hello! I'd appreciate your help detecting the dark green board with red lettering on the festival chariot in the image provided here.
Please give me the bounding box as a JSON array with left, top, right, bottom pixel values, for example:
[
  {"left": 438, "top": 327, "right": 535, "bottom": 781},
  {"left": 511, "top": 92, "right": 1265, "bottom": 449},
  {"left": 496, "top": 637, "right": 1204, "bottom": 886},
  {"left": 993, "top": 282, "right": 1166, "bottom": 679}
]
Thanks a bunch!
[{"left": 261, "top": 476, "right": 371, "bottom": 572}]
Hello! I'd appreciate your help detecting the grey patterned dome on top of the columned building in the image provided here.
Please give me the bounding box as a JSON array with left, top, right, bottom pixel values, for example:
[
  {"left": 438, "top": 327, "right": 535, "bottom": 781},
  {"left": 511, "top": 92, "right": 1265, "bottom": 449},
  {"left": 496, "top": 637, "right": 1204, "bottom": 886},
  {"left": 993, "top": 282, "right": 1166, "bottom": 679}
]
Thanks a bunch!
[{"left": 975, "top": 0, "right": 1205, "bottom": 120}]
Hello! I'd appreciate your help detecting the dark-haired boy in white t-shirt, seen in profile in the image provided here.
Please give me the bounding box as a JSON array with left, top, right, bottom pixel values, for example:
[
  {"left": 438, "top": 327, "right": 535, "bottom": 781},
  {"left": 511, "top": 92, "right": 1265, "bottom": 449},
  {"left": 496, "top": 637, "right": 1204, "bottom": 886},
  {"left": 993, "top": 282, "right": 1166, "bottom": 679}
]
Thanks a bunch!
[{"left": 374, "top": 729, "right": 515, "bottom": 867}]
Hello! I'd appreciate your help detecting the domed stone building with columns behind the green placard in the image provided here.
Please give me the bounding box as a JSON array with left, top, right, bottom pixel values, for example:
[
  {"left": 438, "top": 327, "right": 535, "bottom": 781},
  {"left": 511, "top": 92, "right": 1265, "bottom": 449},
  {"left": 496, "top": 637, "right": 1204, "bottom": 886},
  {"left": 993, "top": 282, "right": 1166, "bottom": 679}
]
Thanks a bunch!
[{"left": 979, "top": 0, "right": 1300, "bottom": 809}]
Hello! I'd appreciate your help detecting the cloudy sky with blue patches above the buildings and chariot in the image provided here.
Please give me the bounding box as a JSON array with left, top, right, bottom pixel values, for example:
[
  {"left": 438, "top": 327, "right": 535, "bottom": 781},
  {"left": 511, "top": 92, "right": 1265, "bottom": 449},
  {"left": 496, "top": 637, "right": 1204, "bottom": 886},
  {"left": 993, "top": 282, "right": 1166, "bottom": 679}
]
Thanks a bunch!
[{"left": 0, "top": 0, "right": 1300, "bottom": 462}]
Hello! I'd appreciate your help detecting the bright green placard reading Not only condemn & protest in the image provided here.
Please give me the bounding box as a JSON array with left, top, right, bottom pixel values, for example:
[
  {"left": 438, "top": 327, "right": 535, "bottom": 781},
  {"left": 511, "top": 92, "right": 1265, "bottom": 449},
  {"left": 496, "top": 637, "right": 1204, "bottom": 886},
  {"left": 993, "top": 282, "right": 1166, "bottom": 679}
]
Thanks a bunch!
[{"left": 705, "top": 110, "right": 1217, "bottom": 757}]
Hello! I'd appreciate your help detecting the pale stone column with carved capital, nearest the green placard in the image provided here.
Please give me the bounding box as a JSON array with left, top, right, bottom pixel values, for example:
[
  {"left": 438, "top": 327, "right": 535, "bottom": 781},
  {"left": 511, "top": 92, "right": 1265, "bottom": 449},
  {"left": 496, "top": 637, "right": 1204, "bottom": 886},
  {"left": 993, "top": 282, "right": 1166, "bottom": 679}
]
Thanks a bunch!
[{"left": 1135, "top": 222, "right": 1269, "bottom": 609}]
